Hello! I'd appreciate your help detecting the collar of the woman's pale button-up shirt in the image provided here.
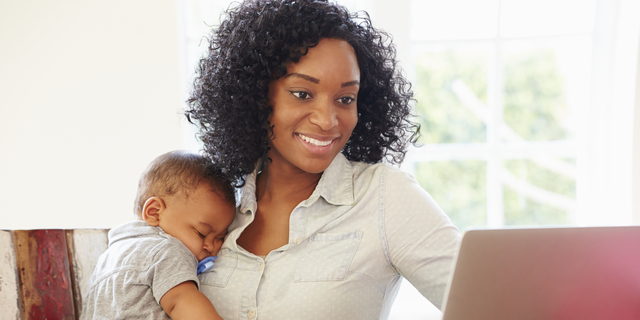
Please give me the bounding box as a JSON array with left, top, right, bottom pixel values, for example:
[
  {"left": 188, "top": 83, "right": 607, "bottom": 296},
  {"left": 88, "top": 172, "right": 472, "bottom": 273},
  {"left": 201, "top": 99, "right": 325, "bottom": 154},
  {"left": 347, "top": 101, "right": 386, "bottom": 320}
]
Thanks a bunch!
[{"left": 240, "top": 153, "right": 354, "bottom": 214}]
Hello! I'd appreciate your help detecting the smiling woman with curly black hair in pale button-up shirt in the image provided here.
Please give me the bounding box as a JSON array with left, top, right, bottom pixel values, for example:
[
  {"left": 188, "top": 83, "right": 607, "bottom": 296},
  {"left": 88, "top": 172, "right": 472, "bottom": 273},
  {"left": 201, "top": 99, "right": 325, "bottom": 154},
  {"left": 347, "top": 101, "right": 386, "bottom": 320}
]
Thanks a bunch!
[{"left": 187, "top": 0, "right": 459, "bottom": 319}]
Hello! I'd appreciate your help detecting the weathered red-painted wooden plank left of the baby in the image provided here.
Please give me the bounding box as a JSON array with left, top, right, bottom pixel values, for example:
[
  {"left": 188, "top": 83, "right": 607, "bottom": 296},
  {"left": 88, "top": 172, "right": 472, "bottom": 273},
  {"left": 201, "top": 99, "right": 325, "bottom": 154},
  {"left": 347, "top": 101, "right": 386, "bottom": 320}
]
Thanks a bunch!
[{"left": 13, "top": 230, "right": 75, "bottom": 320}]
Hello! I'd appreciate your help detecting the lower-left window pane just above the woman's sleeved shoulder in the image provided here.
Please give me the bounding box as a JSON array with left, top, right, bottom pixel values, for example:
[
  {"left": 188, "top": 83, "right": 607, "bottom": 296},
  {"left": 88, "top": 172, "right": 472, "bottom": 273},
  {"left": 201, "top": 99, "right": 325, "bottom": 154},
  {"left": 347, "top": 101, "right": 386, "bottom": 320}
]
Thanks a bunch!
[{"left": 415, "top": 160, "right": 487, "bottom": 230}]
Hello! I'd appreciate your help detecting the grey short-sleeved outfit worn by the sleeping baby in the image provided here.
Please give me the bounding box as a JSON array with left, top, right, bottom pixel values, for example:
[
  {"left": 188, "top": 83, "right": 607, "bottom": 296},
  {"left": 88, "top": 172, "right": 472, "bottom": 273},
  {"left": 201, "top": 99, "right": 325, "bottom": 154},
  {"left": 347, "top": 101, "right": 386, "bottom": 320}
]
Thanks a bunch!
[{"left": 80, "top": 221, "right": 200, "bottom": 320}]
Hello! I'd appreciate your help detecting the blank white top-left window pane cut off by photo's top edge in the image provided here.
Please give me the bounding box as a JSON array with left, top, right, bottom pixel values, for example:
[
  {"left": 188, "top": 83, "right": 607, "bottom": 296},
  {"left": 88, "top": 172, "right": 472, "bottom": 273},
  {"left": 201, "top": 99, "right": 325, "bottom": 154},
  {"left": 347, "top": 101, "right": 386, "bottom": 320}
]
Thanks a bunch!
[{"left": 411, "top": 0, "right": 498, "bottom": 40}]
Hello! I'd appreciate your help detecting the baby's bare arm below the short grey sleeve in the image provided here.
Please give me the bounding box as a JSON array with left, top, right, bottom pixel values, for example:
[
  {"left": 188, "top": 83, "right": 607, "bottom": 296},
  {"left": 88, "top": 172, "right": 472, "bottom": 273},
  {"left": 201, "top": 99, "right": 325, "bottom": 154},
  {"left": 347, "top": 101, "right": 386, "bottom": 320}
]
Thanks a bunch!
[{"left": 160, "top": 281, "right": 222, "bottom": 320}]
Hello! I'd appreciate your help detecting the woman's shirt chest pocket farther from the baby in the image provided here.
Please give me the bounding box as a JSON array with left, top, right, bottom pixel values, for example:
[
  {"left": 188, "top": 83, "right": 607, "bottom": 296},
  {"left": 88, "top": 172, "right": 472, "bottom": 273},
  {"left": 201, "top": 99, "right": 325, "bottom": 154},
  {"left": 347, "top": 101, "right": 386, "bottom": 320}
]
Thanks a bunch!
[{"left": 294, "top": 231, "right": 362, "bottom": 282}]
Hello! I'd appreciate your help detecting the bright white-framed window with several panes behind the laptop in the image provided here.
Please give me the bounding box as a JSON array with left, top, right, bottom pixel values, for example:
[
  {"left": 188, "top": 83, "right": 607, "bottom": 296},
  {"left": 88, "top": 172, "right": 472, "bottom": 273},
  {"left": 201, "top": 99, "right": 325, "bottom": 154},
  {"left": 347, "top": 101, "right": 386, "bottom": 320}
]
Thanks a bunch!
[{"left": 410, "top": 0, "right": 596, "bottom": 229}]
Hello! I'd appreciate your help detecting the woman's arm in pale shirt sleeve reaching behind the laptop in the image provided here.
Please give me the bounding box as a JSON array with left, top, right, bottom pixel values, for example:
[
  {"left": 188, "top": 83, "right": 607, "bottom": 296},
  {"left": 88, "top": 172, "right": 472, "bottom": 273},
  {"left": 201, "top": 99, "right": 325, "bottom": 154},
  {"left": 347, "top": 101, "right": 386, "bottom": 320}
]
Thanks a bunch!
[{"left": 383, "top": 169, "right": 460, "bottom": 308}]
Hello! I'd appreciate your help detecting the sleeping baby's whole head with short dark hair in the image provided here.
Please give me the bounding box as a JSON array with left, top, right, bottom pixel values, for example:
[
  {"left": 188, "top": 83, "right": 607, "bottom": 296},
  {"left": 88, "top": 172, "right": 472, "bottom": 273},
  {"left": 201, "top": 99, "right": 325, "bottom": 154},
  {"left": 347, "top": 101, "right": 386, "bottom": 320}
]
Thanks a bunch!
[{"left": 134, "top": 151, "right": 236, "bottom": 261}]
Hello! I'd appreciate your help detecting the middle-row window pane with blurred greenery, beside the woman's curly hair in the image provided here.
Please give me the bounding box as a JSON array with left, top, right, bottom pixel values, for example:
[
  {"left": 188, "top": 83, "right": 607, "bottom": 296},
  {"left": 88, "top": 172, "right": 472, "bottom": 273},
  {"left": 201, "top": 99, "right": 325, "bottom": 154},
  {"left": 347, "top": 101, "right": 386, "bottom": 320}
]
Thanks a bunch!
[{"left": 414, "top": 49, "right": 488, "bottom": 143}]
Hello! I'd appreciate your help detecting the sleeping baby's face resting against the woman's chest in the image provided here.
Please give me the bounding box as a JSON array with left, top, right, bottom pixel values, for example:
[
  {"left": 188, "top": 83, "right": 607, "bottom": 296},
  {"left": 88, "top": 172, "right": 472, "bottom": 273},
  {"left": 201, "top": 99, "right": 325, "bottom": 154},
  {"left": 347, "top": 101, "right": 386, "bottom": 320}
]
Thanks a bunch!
[{"left": 160, "top": 183, "right": 235, "bottom": 261}]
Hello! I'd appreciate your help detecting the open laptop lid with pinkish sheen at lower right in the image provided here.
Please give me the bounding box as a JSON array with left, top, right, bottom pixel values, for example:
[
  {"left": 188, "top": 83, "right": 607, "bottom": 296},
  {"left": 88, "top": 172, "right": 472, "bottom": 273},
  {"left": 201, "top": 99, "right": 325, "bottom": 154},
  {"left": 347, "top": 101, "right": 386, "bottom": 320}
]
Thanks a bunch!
[{"left": 442, "top": 226, "right": 640, "bottom": 320}]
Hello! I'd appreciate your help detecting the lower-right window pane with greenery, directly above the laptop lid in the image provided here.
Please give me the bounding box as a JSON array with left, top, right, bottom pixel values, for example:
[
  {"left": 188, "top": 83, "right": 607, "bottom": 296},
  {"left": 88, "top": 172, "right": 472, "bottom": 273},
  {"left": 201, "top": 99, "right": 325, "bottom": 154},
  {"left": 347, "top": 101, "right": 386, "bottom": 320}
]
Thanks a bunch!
[{"left": 501, "top": 158, "right": 576, "bottom": 225}]
